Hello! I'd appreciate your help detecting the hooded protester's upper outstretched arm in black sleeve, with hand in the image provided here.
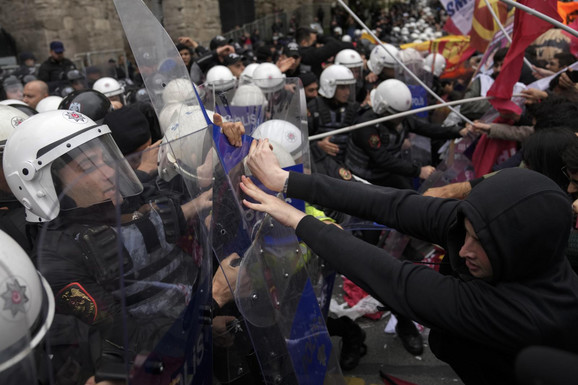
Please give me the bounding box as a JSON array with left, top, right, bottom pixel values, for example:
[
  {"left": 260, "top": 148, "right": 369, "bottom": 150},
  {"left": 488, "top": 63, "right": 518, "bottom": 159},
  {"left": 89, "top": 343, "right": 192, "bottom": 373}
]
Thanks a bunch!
[{"left": 242, "top": 140, "right": 458, "bottom": 245}]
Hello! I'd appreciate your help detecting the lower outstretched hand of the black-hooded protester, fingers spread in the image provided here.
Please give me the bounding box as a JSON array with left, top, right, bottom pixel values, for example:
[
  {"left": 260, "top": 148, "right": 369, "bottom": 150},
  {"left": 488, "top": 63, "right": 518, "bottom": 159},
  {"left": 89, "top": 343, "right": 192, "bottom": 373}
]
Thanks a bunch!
[{"left": 240, "top": 176, "right": 305, "bottom": 229}]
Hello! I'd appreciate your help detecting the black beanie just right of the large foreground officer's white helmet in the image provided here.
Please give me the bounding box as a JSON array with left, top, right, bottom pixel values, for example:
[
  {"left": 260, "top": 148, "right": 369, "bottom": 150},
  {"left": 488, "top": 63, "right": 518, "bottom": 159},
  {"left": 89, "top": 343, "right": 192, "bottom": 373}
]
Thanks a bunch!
[{"left": 103, "top": 106, "right": 151, "bottom": 155}]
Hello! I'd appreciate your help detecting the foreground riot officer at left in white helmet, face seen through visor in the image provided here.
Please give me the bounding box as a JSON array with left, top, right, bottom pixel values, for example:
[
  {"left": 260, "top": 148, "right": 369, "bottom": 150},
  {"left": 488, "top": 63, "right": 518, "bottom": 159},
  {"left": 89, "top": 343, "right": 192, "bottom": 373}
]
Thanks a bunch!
[{"left": 4, "top": 110, "right": 211, "bottom": 382}]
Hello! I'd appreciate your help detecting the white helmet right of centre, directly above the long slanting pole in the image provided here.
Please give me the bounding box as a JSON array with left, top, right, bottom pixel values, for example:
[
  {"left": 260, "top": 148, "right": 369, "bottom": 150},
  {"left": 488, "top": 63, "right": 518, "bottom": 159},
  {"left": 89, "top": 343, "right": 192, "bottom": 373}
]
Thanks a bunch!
[{"left": 369, "top": 79, "right": 411, "bottom": 115}]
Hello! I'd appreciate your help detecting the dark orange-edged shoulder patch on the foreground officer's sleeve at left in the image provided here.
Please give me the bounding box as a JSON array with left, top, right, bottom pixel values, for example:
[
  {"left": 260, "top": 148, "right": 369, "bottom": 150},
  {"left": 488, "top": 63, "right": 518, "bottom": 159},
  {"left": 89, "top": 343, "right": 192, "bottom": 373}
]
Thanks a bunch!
[{"left": 56, "top": 282, "right": 98, "bottom": 324}]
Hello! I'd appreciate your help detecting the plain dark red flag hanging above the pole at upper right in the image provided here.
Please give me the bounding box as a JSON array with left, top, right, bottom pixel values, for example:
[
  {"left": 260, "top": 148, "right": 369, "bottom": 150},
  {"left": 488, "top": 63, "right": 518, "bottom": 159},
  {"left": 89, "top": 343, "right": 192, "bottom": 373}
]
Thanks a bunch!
[{"left": 488, "top": 0, "right": 561, "bottom": 115}]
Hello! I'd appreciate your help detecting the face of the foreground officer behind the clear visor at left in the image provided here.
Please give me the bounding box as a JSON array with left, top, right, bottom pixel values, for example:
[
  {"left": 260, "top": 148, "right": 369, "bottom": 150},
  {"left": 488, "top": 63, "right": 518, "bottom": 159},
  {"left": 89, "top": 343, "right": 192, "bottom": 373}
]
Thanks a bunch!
[{"left": 58, "top": 146, "right": 122, "bottom": 207}]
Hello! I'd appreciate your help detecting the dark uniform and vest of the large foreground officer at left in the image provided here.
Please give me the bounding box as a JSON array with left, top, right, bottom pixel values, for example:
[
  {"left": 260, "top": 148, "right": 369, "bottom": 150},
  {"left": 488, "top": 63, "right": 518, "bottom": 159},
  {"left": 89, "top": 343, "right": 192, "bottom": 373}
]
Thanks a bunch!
[{"left": 36, "top": 200, "right": 200, "bottom": 379}]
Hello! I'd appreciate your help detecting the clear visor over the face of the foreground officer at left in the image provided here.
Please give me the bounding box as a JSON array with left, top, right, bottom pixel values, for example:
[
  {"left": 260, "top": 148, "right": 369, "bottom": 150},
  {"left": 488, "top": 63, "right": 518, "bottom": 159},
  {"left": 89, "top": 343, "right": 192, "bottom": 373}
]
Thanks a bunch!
[{"left": 51, "top": 134, "right": 143, "bottom": 210}]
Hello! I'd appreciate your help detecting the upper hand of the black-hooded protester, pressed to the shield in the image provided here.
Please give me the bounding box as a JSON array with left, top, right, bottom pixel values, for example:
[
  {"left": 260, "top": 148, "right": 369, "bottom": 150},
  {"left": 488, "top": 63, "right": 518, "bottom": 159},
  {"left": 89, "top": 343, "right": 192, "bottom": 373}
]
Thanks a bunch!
[{"left": 247, "top": 139, "right": 289, "bottom": 192}]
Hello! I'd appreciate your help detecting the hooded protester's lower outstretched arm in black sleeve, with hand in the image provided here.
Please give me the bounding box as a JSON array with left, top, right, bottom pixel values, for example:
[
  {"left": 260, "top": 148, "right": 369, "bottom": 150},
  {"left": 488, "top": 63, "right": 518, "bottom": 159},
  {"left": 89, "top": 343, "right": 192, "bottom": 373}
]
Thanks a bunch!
[{"left": 241, "top": 174, "right": 530, "bottom": 352}]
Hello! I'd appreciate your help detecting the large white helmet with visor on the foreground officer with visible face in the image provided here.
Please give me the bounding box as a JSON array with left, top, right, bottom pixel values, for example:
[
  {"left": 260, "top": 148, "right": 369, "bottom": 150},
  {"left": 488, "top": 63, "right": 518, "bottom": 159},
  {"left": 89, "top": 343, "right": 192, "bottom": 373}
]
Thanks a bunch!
[{"left": 3, "top": 110, "right": 142, "bottom": 222}]
